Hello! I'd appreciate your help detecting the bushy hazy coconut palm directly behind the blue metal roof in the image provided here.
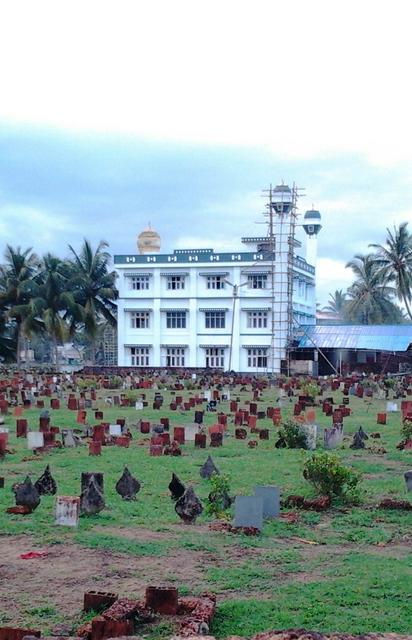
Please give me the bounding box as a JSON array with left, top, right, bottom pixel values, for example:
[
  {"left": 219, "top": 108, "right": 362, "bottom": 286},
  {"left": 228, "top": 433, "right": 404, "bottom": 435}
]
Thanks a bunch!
[{"left": 346, "top": 254, "right": 402, "bottom": 324}]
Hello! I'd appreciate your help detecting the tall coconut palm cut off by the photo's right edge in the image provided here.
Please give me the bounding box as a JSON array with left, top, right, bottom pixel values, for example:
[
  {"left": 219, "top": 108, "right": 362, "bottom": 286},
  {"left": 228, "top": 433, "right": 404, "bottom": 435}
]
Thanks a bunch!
[{"left": 369, "top": 222, "right": 412, "bottom": 320}]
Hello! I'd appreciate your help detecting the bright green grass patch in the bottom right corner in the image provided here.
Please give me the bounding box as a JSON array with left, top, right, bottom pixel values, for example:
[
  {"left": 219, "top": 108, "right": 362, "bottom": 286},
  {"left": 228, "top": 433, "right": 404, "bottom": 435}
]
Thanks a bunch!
[{"left": 211, "top": 553, "right": 412, "bottom": 638}]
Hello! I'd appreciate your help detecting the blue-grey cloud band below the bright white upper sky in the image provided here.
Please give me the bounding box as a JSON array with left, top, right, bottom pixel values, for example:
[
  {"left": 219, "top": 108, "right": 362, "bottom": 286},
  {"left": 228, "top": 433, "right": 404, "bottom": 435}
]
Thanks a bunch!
[{"left": 0, "top": 127, "right": 411, "bottom": 303}]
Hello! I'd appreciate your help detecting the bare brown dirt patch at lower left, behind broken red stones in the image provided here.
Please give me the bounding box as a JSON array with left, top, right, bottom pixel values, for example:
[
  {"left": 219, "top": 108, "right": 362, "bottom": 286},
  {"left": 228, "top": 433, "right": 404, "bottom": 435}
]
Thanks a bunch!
[{"left": 0, "top": 536, "right": 210, "bottom": 626}]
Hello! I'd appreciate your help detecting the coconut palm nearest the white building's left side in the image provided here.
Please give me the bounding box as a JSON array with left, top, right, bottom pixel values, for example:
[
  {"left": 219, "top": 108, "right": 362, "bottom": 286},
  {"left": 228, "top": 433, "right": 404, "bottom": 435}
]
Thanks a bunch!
[{"left": 69, "top": 240, "right": 118, "bottom": 362}]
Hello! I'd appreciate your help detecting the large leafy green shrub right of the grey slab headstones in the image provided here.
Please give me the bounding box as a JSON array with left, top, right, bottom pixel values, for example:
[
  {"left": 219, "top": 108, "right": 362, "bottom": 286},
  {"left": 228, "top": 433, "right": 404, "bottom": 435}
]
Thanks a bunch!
[{"left": 303, "top": 452, "right": 360, "bottom": 504}]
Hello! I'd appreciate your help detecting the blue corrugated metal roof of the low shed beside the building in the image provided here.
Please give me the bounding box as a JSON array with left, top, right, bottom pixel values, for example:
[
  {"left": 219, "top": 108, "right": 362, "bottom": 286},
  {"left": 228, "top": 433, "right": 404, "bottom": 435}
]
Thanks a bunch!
[{"left": 298, "top": 324, "right": 412, "bottom": 351}]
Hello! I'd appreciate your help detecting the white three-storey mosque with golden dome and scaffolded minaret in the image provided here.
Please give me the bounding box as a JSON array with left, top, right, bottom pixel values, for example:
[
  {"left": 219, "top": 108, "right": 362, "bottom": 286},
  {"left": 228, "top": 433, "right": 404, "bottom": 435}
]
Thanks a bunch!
[{"left": 114, "top": 185, "right": 321, "bottom": 373}]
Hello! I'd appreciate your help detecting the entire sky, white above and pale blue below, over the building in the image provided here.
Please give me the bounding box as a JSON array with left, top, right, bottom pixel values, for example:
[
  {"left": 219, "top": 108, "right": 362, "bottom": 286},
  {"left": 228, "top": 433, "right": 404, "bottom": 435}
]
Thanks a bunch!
[{"left": 0, "top": 0, "right": 412, "bottom": 304}]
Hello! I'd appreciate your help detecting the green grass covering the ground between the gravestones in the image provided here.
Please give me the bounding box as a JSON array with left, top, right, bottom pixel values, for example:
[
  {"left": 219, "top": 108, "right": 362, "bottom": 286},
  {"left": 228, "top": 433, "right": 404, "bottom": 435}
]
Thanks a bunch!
[{"left": 0, "top": 384, "right": 412, "bottom": 638}]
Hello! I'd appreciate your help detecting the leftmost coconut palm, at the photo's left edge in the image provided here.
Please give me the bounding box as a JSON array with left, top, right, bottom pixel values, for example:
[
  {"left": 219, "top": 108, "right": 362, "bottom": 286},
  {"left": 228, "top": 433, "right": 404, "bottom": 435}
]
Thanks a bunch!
[{"left": 0, "top": 245, "right": 39, "bottom": 367}]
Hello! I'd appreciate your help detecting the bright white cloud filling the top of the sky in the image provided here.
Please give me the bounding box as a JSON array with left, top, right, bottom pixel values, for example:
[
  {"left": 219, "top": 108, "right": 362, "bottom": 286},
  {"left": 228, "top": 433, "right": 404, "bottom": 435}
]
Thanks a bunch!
[{"left": 0, "top": 0, "right": 412, "bottom": 167}]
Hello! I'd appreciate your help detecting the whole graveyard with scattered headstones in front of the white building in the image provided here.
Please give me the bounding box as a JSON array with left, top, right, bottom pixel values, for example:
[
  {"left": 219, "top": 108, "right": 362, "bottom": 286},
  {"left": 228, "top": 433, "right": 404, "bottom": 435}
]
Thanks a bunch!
[{"left": 0, "top": 371, "right": 412, "bottom": 640}]
